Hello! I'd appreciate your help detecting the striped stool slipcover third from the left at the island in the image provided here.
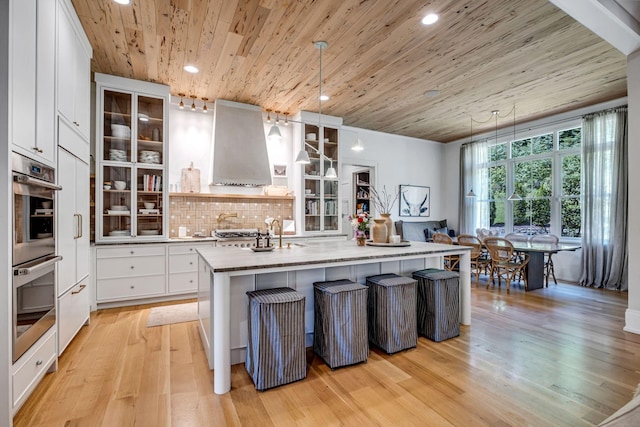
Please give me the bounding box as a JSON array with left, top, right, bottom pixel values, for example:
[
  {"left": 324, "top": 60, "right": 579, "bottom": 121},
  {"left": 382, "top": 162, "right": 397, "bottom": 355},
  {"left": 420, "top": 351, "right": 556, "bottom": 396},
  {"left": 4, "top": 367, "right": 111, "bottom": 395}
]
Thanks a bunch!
[{"left": 367, "top": 274, "right": 418, "bottom": 353}]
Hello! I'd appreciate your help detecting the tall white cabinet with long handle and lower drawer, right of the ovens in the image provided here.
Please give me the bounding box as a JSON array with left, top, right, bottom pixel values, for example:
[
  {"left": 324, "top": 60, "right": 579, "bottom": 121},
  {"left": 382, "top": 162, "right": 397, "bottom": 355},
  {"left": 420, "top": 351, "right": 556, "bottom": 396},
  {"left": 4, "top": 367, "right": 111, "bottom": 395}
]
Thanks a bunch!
[{"left": 56, "top": 149, "right": 90, "bottom": 354}]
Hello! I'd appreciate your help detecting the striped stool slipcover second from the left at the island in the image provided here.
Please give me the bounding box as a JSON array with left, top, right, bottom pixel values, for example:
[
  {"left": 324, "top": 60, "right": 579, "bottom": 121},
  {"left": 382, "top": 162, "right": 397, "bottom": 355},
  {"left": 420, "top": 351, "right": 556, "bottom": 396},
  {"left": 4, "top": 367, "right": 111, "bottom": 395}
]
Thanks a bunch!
[{"left": 313, "top": 280, "right": 369, "bottom": 369}]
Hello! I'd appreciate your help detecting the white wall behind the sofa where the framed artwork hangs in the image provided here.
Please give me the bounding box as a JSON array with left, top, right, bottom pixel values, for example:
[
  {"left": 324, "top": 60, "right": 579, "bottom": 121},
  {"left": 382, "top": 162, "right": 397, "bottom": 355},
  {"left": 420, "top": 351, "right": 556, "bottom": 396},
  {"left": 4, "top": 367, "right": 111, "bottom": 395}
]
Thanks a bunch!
[{"left": 340, "top": 126, "right": 444, "bottom": 226}]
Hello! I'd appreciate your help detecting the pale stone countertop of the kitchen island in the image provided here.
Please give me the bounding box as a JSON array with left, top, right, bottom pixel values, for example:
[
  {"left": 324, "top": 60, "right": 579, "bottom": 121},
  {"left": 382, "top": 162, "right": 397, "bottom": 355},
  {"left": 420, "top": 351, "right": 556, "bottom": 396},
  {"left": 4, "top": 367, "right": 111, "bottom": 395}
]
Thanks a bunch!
[{"left": 198, "top": 240, "right": 470, "bottom": 273}]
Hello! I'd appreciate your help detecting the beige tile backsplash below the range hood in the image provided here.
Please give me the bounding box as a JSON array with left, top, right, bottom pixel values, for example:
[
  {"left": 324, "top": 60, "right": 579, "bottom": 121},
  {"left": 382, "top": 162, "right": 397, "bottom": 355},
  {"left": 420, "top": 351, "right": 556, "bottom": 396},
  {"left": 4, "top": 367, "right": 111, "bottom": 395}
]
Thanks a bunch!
[{"left": 169, "top": 195, "right": 295, "bottom": 237}]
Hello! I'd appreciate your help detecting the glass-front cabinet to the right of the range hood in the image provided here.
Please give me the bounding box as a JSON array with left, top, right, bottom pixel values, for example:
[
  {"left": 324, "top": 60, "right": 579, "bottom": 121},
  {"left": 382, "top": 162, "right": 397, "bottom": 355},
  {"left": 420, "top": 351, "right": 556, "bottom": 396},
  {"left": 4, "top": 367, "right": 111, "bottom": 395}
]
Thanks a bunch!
[{"left": 300, "top": 115, "right": 341, "bottom": 233}]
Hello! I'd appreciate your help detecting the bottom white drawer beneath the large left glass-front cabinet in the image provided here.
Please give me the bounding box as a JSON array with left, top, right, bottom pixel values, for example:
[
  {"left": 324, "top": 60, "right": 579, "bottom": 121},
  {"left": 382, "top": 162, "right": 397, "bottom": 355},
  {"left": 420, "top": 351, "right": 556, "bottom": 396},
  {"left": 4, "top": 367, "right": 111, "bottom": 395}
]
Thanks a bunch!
[{"left": 96, "top": 273, "right": 165, "bottom": 301}]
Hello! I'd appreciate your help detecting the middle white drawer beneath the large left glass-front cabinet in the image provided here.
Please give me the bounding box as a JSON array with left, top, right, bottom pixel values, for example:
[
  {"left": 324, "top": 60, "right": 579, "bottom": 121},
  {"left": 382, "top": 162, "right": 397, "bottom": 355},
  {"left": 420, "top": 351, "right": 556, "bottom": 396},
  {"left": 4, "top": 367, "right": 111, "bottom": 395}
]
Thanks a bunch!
[{"left": 96, "top": 254, "right": 165, "bottom": 280}]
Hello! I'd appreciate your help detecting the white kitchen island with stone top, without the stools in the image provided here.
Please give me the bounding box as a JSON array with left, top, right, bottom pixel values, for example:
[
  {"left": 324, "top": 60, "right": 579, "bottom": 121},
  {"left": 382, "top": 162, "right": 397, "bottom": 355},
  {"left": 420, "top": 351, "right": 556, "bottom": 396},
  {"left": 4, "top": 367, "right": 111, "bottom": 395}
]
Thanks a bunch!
[{"left": 198, "top": 241, "right": 471, "bottom": 394}]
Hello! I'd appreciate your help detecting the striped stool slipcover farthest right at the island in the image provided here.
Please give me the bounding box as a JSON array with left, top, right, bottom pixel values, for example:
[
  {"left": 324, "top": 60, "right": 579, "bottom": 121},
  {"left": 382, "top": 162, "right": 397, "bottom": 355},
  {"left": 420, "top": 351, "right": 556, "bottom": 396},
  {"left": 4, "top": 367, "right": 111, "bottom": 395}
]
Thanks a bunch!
[{"left": 413, "top": 268, "right": 460, "bottom": 342}]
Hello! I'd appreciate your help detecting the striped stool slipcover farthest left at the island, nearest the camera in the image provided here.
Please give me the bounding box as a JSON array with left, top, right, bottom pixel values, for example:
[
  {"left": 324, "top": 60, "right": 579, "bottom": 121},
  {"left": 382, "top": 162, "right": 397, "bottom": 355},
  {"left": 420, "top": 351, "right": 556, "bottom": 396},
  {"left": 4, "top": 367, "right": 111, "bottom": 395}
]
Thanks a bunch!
[{"left": 245, "top": 288, "right": 307, "bottom": 390}]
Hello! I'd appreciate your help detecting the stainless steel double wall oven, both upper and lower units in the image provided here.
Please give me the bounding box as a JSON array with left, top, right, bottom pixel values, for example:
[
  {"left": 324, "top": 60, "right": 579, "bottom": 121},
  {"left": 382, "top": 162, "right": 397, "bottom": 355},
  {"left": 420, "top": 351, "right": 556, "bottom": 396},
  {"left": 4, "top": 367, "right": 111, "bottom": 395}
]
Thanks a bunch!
[{"left": 12, "top": 153, "right": 62, "bottom": 362}]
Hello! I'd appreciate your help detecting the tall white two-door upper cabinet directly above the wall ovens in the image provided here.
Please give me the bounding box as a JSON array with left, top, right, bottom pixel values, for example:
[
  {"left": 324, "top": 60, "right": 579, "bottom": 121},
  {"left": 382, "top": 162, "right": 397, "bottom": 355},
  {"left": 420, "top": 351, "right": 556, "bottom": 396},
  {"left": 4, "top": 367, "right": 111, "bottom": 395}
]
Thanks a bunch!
[{"left": 9, "top": 0, "right": 56, "bottom": 166}]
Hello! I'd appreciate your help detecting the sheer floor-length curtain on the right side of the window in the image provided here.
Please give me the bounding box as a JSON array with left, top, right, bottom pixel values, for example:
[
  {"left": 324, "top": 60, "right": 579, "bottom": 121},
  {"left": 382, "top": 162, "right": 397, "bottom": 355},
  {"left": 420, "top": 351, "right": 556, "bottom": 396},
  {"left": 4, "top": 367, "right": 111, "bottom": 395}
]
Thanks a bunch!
[{"left": 580, "top": 107, "right": 628, "bottom": 290}]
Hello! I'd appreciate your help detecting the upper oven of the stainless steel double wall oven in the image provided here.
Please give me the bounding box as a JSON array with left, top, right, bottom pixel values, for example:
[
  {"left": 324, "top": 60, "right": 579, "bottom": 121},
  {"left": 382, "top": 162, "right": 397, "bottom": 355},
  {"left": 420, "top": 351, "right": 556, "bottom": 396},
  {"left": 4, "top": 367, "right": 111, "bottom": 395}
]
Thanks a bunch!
[{"left": 12, "top": 153, "right": 61, "bottom": 266}]
